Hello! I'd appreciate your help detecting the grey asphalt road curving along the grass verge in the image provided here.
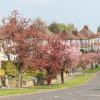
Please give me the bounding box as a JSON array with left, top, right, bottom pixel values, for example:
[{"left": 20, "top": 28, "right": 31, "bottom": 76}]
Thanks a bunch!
[{"left": 0, "top": 72, "right": 100, "bottom": 100}]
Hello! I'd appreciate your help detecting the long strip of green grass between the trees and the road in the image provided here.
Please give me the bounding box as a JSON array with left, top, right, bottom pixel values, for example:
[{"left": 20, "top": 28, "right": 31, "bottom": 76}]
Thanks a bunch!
[{"left": 0, "top": 67, "right": 100, "bottom": 96}]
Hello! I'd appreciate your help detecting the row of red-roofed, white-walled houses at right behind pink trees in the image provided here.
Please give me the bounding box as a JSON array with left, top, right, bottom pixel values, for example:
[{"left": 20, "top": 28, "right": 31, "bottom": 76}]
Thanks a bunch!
[{"left": 63, "top": 25, "right": 100, "bottom": 52}]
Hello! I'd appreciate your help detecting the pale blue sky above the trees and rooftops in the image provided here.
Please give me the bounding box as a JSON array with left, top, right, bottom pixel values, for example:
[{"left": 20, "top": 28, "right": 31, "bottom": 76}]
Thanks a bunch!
[{"left": 0, "top": 0, "right": 100, "bottom": 32}]
